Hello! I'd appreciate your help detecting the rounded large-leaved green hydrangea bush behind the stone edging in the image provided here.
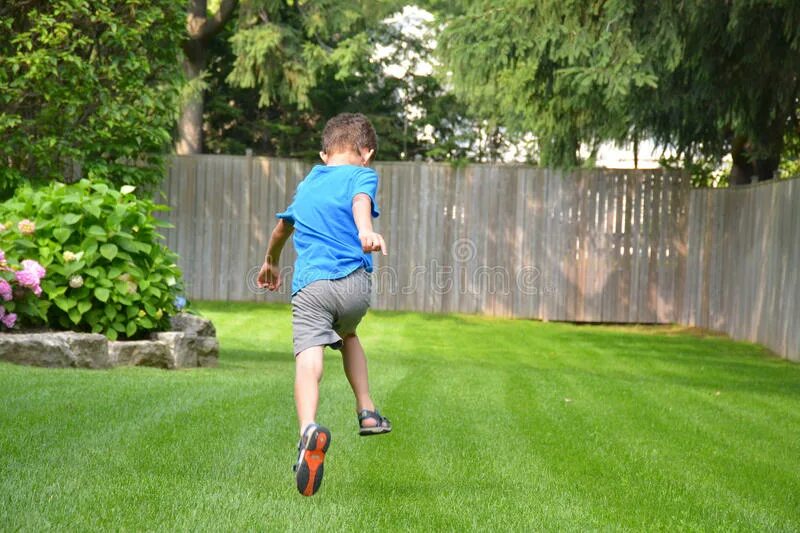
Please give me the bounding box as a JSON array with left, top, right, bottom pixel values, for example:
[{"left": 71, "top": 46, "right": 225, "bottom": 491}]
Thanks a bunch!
[{"left": 0, "top": 180, "right": 182, "bottom": 339}]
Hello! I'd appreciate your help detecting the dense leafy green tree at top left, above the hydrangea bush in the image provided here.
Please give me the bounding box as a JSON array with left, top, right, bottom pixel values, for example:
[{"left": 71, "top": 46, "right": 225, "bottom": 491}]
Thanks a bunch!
[{"left": 0, "top": 0, "right": 183, "bottom": 191}]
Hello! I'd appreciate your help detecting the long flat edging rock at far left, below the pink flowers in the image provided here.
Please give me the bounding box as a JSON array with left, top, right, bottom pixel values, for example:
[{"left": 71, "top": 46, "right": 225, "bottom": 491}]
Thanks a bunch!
[{"left": 0, "top": 331, "right": 112, "bottom": 368}]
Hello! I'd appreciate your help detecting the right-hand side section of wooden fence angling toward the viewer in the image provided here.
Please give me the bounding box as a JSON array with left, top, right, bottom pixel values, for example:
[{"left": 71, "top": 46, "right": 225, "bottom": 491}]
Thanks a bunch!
[{"left": 678, "top": 179, "right": 800, "bottom": 361}]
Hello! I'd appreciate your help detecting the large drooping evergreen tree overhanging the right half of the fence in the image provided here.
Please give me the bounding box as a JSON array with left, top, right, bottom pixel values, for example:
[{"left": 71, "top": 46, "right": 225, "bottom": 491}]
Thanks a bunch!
[{"left": 433, "top": 0, "right": 800, "bottom": 183}]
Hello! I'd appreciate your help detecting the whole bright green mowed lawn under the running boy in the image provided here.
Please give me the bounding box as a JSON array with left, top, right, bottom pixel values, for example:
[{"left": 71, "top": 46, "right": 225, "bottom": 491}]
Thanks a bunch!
[{"left": 0, "top": 303, "right": 800, "bottom": 531}]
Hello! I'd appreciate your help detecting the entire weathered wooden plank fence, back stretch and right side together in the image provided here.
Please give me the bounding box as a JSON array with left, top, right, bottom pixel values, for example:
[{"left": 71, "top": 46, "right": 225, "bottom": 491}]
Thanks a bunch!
[{"left": 159, "top": 156, "right": 800, "bottom": 358}]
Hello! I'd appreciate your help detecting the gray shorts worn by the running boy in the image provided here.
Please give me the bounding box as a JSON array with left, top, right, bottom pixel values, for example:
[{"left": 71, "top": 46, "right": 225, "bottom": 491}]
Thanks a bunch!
[{"left": 292, "top": 268, "right": 372, "bottom": 355}]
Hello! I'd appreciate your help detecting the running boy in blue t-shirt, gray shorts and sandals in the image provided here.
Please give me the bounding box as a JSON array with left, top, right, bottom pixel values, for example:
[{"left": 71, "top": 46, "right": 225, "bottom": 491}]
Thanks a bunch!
[{"left": 258, "top": 113, "right": 392, "bottom": 496}]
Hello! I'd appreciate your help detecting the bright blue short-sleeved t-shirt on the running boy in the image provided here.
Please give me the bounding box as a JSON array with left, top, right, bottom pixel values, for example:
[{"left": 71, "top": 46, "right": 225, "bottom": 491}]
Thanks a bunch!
[{"left": 275, "top": 165, "right": 380, "bottom": 294}]
